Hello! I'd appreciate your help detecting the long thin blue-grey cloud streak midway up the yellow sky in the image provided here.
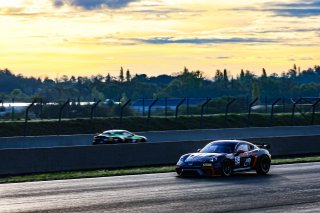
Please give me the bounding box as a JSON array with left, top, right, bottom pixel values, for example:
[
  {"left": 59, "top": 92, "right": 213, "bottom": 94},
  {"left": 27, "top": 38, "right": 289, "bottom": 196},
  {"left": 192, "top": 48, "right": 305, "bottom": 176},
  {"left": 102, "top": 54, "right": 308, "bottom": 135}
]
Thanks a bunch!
[{"left": 132, "top": 37, "right": 276, "bottom": 44}]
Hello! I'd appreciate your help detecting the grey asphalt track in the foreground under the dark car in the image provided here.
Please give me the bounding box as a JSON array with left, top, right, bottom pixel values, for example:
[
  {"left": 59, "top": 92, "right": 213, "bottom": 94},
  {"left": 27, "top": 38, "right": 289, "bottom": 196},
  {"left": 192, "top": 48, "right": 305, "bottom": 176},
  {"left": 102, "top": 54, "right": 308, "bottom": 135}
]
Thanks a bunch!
[{"left": 0, "top": 163, "right": 320, "bottom": 212}]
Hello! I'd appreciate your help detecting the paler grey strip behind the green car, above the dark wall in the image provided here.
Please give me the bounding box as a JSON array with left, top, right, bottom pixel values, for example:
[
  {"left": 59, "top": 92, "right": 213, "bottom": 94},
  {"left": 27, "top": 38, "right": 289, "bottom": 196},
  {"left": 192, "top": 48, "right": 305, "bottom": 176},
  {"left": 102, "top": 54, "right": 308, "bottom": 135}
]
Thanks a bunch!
[{"left": 0, "top": 125, "right": 320, "bottom": 149}]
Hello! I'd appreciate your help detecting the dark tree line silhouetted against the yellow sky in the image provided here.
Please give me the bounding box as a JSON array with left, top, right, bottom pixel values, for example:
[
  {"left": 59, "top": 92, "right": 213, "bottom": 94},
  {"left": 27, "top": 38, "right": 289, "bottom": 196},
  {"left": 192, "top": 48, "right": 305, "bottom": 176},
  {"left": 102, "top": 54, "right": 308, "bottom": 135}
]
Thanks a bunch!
[{"left": 0, "top": 65, "right": 320, "bottom": 101}]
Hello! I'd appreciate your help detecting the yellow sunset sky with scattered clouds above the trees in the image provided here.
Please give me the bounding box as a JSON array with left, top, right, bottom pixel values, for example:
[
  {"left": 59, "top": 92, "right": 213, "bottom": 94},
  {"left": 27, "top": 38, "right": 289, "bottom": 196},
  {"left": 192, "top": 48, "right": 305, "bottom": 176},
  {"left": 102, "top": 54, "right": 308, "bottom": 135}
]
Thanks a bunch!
[{"left": 0, "top": 0, "right": 320, "bottom": 78}]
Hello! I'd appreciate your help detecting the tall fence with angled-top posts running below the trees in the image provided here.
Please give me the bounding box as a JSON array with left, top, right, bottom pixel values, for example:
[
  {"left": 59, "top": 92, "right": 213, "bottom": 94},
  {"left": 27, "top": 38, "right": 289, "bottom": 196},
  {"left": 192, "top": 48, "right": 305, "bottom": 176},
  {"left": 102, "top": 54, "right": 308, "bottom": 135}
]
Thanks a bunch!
[{"left": 0, "top": 96, "right": 320, "bottom": 135}]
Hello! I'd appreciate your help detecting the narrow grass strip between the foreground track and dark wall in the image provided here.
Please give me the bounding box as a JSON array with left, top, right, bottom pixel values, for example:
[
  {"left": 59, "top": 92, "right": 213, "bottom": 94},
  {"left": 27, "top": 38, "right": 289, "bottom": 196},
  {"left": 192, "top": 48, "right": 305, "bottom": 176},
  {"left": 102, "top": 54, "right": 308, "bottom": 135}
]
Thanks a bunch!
[{"left": 0, "top": 156, "right": 320, "bottom": 183}]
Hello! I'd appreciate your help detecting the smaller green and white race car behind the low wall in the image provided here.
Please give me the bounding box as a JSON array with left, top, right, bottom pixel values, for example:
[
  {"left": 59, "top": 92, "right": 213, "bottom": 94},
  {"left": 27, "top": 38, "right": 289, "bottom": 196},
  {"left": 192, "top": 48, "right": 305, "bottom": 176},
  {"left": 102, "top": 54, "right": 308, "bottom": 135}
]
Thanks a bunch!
[{"left": 92, "top": 130, "right": 147, "bottom": 145}]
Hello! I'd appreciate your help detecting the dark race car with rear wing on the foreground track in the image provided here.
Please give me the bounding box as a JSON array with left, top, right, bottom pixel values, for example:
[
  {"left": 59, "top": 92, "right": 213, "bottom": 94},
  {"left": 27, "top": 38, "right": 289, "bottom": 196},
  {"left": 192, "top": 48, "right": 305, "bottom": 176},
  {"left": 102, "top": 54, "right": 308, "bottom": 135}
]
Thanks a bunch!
[{"left": 176, "top": 140, "right": 271, "bottom": 176}]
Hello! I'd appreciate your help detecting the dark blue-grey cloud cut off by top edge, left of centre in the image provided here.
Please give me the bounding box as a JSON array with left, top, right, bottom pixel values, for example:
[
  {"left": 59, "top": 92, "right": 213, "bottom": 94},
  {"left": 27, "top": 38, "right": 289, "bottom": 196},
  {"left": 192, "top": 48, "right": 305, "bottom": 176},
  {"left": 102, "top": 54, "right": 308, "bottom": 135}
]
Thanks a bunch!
[{"left": 53, "top": 0, "right": 137, "bottom": 10}]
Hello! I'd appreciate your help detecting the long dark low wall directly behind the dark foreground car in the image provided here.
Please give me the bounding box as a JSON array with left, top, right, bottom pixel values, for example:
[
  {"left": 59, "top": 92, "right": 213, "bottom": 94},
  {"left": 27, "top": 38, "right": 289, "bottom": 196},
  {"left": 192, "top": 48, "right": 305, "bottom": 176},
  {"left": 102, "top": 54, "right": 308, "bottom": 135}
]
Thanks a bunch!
[{"left": 0, "top": 135, "right": 320, "bottom": 175}]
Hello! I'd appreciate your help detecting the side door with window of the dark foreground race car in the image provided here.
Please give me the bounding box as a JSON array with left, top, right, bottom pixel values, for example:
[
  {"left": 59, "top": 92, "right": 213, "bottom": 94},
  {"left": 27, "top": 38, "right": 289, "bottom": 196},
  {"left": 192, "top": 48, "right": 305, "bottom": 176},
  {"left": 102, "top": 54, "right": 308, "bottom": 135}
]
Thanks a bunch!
[{"left": 235, "top": 143, "right": 252, "bottom": 168}]
